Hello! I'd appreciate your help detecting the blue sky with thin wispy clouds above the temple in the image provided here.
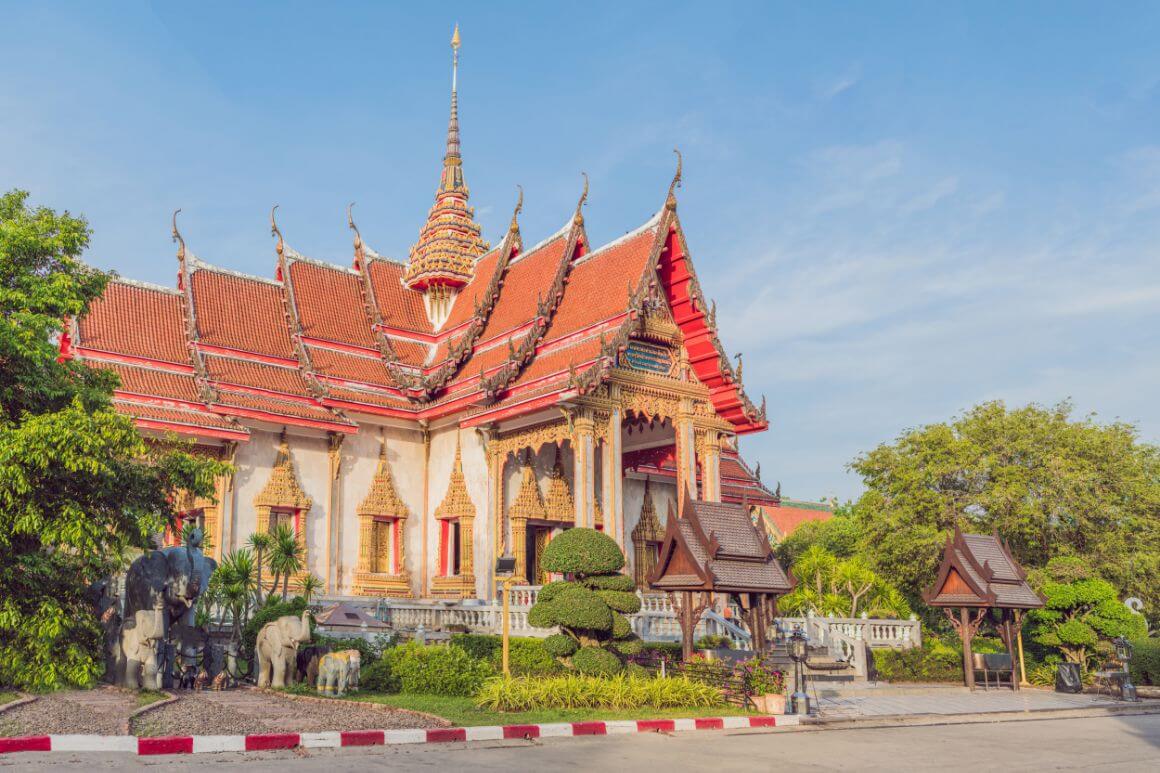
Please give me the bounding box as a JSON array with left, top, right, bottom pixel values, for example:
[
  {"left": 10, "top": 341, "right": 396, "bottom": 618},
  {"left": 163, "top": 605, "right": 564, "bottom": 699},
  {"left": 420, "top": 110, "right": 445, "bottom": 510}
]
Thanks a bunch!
[{"left": 0, "top": 2, "right": 1160, "bottom": 499}]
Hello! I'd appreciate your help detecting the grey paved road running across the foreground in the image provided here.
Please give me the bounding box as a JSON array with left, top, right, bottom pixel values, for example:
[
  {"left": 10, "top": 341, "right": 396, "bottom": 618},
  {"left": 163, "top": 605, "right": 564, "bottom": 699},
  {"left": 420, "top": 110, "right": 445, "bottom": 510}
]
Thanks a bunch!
[{"left": 0, "top": 715, "right": 1160, "bottom": 773}]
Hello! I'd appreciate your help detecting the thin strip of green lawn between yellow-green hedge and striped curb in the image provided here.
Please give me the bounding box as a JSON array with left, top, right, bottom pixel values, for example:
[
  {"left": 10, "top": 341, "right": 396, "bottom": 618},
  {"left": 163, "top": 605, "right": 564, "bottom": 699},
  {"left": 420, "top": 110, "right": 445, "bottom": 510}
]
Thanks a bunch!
[{"left": 351, "top": 693, "right": 749, "bottom": 727}]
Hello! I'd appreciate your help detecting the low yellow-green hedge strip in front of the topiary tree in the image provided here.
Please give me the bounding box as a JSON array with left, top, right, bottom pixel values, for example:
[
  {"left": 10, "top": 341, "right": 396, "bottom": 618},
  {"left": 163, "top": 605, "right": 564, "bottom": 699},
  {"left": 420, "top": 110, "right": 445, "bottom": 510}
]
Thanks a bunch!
[{"left": 476, "top": 673, "right": 723, "bottom": 711}]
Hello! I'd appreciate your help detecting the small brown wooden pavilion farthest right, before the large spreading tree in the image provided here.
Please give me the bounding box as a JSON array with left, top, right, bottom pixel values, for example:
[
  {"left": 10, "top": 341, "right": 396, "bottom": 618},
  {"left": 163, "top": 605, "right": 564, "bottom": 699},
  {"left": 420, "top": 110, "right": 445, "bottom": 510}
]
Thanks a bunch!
[{"left": 922, "top": 526, "right": 1044, "bottom": 689}]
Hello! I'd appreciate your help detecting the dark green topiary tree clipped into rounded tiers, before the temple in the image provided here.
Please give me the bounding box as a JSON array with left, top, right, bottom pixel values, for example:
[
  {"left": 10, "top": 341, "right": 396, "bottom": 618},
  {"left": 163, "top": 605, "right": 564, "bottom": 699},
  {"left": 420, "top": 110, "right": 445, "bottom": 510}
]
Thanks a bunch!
[{"left": 528, "top": 528, "right": 640, "bottom": 672}]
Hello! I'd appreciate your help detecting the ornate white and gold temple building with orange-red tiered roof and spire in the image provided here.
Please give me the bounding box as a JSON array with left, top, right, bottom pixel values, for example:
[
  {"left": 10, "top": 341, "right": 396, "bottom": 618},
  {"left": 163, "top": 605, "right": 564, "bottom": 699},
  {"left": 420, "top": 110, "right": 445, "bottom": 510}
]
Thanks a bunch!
[{"left": 61, "top": 31, "right": 798, "bottom": 598}]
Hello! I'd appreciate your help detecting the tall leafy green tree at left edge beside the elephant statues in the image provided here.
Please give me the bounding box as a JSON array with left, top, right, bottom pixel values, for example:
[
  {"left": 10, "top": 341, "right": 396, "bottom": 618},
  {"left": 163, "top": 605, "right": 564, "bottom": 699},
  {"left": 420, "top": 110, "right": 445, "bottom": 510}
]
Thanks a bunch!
[{"left": 0, "top": 190, "right": 226, "bottom": 689}]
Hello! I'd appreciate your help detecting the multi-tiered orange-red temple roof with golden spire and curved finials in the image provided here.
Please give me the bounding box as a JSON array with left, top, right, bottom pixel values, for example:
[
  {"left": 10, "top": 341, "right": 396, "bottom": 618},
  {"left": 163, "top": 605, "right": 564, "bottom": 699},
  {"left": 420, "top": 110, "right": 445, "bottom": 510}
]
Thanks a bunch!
[{"left": 61, "top": 30, "right": 767, "bottom": 439}]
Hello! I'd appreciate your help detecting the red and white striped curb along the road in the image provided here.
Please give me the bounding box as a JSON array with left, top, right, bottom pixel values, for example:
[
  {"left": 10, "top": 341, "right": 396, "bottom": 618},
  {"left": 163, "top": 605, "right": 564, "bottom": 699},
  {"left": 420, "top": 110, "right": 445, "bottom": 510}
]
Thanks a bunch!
[{"left": 0, "top": 716, "right": 798, "bottom": 754}]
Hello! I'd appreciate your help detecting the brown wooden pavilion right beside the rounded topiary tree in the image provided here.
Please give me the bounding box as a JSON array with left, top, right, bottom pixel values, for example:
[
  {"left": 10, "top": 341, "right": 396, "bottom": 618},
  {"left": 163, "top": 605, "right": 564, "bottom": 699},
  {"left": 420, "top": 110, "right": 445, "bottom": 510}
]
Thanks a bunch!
[{"left": 648, "top": 492, "right": 793, "bottom": 658}]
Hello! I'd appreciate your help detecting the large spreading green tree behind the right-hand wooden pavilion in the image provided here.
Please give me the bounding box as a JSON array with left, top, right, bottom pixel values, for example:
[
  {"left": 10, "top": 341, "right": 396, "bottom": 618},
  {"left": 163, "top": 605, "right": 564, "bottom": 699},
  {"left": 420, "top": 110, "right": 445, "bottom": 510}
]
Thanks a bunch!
[{"left": 850, "top": 402, "right": 1160, "bottom": 615}]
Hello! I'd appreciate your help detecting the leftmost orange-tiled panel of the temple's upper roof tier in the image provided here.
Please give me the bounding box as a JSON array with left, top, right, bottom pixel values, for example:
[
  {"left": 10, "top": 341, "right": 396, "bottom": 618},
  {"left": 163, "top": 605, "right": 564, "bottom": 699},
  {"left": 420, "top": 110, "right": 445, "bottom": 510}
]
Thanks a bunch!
[{"left": 77, "top": 280, "right": 189, "bottom": 364}]
